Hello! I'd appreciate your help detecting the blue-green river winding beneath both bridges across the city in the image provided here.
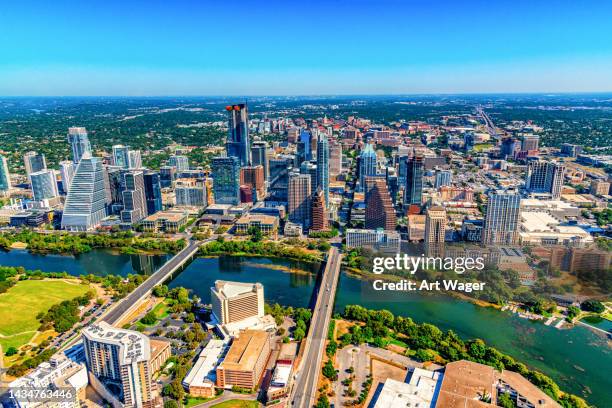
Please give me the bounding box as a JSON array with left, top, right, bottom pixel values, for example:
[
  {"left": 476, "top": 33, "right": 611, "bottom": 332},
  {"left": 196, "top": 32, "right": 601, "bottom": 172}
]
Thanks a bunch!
[{"left": 0, "top": 250, "right": 612, "bottom": 408}]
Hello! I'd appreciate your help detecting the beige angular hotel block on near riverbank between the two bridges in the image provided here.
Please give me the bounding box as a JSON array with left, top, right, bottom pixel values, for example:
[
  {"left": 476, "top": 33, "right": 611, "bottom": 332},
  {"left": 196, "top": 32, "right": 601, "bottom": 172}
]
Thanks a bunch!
[{"left": 210, "top": 280, "right": 264, "bottom": 324}]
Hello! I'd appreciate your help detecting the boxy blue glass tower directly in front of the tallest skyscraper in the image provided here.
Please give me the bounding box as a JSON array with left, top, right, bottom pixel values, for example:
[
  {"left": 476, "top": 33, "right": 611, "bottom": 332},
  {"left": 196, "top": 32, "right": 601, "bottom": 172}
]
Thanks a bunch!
[{"left": 212, "top": 156, "right": 240, "bottom": 205}]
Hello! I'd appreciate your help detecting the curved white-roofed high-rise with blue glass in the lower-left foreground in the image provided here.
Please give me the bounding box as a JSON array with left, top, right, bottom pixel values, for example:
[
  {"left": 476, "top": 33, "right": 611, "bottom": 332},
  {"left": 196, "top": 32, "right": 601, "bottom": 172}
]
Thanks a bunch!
[{"left": 82, "top": 322, "right": 154, "bottom": 408}]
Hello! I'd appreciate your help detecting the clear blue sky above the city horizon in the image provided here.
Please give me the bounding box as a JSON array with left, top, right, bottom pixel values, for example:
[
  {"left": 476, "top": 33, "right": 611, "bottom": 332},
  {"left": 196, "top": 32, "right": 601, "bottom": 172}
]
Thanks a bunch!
[{"left": 0, "top": 0, "right": 612, "bottom": 95}]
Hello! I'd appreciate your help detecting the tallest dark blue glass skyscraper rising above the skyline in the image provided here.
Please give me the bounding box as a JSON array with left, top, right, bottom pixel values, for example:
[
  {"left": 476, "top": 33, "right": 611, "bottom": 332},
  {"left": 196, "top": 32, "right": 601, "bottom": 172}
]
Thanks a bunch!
[{"left": 225, "top": 103, "right": 251, "bottom": 166}]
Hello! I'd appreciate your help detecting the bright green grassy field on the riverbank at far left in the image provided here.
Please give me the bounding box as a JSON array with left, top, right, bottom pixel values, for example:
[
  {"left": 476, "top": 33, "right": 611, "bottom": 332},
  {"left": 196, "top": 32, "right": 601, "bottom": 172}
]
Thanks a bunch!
[{"left": 0, "top": 280, "right": 90, "bottom": 350}]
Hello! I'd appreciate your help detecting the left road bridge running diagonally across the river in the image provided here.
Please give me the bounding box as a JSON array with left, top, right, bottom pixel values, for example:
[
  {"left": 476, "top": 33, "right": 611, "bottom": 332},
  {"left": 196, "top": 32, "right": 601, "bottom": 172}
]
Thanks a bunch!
[{"left": 101, "top": 240, "right": 204, "bottom": 325}]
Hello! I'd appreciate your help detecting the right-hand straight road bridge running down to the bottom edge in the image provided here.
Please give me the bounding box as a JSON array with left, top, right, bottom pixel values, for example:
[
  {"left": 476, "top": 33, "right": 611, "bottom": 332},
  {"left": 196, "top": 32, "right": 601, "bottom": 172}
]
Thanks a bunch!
[{"left": 291, "top": 247, "right": 342, "bottom": 408}]
